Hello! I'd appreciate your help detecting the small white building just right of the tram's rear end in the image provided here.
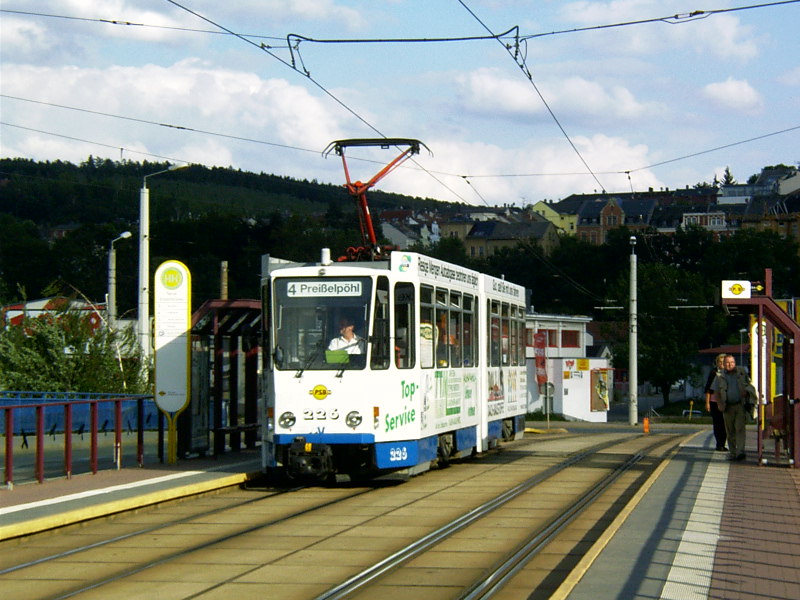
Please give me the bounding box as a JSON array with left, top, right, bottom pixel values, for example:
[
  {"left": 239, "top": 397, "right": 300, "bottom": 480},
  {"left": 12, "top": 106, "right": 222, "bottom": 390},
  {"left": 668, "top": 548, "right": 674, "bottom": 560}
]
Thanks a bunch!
[{"left": 526, "top": 313, "right": 614, "bottom": 423}]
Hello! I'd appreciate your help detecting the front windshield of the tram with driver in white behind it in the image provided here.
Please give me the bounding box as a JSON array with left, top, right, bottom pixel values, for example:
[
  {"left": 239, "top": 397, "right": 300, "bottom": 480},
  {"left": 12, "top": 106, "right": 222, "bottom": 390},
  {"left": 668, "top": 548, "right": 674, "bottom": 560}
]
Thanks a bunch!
[{"left": 272, "top": 277, "right": 372, "bottom": 371}]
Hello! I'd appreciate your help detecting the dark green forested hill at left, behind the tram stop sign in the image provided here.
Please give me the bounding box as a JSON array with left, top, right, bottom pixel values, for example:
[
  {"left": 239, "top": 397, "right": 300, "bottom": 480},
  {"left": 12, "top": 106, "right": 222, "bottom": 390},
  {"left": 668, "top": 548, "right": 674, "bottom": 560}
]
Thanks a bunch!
[{"left": 0, "top": 157, "right": 454, "bottom": 315}]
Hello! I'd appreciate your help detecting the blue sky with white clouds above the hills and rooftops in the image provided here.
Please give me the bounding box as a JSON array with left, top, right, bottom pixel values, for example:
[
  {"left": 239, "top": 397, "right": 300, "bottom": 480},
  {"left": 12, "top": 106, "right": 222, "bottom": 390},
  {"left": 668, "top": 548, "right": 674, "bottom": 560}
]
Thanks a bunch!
[{"left": 0, "top": 0, "right": 800, "bottom": 206}]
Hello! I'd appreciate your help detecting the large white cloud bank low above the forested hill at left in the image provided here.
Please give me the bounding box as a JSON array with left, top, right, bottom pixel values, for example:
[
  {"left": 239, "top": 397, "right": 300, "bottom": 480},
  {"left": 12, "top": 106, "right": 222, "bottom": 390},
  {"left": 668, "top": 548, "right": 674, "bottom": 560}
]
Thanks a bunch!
[{"left": 1, "top": 59, "right": 342, "bottom": 172}]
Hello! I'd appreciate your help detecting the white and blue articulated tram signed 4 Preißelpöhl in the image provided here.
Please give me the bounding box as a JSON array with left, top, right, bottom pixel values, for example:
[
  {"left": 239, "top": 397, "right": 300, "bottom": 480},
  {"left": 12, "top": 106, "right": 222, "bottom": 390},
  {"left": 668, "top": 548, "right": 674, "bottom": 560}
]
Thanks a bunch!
[{"left": 262, "top": 250, "right": 527, "bottom": 479}]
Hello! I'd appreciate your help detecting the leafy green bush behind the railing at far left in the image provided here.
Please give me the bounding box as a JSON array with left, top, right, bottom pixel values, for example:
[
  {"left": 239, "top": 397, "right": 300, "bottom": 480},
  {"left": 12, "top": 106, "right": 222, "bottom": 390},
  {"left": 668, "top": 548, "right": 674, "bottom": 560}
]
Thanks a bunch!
[{"left": 0, "top": 301, "right": 147, "bottom": 394}]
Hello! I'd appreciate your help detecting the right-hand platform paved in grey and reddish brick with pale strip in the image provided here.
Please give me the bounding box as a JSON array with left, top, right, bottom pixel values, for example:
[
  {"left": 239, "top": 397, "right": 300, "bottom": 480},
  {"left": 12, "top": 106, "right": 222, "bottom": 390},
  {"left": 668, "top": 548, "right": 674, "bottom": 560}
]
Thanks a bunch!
[{"left": 551, "top": 426, "right": 800, "bottom": 600}]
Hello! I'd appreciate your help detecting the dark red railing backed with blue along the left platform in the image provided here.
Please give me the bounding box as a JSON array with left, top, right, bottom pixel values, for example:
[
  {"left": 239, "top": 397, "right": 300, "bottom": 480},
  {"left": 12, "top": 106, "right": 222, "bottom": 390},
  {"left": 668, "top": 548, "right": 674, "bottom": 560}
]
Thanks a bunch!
[{"left": 0, "top": 392, "right": 159, "bottom": 487}]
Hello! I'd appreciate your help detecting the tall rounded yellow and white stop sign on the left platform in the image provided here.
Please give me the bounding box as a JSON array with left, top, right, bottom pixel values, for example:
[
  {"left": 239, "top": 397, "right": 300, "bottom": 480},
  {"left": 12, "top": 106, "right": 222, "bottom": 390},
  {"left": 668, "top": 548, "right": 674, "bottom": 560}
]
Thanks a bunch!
[{"left": 153, "top": 260, "right": 192, "bottom": 464}]
